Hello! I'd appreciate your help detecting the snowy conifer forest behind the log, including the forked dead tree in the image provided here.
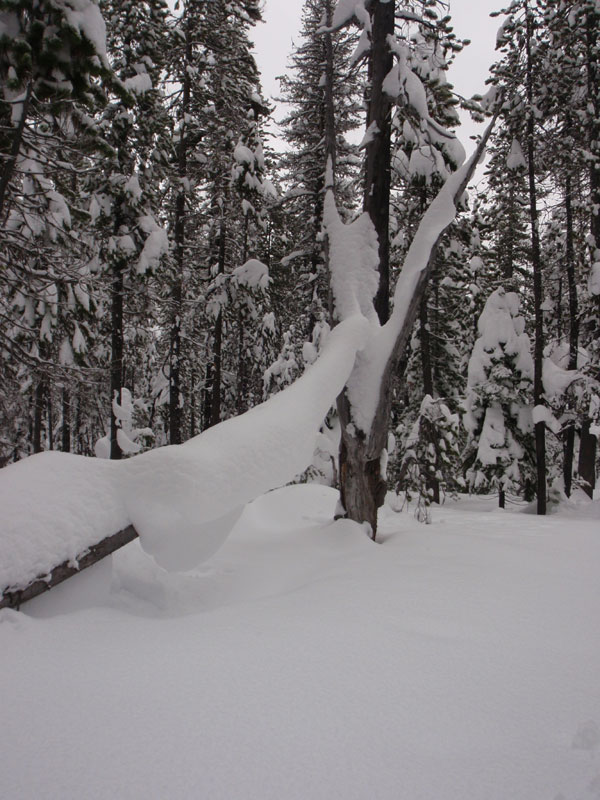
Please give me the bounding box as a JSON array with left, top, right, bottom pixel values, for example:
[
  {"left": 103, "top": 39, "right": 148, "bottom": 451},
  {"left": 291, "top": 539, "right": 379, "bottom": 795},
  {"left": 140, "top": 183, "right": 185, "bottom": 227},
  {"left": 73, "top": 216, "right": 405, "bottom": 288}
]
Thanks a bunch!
[{"left": 0, "top": 0, "right": 600, "bottom": 524}]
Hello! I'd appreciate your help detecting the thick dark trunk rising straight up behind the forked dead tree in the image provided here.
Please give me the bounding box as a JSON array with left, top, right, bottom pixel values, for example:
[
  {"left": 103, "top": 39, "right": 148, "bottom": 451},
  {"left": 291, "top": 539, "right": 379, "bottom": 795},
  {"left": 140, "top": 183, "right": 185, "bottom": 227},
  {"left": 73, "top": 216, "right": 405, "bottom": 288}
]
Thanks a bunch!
[{"left": 363, "top": 0, "right": 396, "bottom": 324}]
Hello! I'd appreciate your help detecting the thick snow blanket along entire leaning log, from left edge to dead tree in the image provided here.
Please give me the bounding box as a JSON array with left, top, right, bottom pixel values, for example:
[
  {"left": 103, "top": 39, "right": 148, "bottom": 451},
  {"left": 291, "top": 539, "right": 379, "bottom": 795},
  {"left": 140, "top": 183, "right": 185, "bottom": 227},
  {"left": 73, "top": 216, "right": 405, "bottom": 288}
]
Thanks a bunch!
[{"left": 0, "top": 316, "right": 368, "bottom": 589}]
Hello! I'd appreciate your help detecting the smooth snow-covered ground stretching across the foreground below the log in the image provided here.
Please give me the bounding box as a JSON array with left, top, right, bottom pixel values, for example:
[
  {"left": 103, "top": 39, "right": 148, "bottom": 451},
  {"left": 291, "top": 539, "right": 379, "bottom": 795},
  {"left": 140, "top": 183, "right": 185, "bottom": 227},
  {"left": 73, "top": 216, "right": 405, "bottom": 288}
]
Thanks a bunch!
[{"left": 0, "top": 485, "right": 600, "bottom": 800}]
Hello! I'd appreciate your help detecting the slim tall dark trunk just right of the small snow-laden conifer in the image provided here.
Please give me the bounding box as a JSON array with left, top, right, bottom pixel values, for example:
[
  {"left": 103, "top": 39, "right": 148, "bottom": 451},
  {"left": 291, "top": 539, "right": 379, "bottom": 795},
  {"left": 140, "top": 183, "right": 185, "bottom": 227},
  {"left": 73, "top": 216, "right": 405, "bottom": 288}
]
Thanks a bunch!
[{"left": 525, "top": 2, "right": 547, "bottom": 515}]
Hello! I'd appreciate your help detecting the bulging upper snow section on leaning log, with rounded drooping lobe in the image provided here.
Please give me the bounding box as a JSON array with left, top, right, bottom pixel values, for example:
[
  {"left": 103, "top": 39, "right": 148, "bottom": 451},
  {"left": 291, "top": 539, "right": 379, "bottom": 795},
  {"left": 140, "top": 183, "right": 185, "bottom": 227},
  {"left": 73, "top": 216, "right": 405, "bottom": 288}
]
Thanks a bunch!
[{"left": 123, "top": 317, "right": 368, "bottom": 569}]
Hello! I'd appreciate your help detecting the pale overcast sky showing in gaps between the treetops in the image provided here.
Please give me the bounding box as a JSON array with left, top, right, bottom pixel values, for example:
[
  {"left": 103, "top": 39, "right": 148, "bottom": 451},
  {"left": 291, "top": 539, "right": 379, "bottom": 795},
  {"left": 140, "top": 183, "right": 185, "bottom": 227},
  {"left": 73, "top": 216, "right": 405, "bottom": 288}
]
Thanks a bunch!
[{"left": 252, "top": 0, "right": 502, "bottom": 150}]
